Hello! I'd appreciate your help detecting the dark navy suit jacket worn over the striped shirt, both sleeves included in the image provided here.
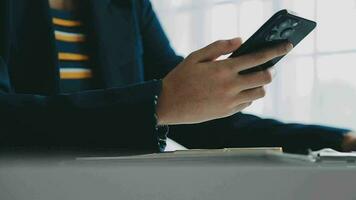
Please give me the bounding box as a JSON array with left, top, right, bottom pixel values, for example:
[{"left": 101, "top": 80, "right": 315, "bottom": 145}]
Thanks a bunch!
[{"left": 0, "top": 0, "right": 346, "bottom": 152}]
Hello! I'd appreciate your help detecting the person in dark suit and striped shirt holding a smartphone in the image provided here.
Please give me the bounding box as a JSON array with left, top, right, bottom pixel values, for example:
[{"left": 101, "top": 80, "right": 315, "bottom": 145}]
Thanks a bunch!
[{"left": 0, "top": 0, "right": 356, "bottom": 153}]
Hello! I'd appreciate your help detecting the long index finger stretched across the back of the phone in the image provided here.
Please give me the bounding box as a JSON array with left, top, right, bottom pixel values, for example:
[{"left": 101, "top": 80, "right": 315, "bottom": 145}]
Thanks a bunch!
[{"left": 215, "top": 43, "right": 293, "bottom": 72}]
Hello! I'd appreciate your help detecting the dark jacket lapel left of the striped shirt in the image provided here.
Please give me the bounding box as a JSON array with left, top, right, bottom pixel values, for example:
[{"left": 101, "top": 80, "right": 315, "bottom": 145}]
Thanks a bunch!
[{"left": 9, "top": 0, "right": 59, "bottom": 94}]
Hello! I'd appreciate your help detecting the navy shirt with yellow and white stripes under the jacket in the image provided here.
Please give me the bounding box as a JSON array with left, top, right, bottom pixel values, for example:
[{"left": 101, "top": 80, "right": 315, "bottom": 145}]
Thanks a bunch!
[{"left": 51, "top": 9, "right": 93, "bottom": 93}]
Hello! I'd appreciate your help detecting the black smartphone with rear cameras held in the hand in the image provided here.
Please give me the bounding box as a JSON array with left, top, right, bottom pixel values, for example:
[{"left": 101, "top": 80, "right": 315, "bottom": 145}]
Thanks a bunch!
[{"left": 230, "top": 10, "right": 317, "bottom": 74}]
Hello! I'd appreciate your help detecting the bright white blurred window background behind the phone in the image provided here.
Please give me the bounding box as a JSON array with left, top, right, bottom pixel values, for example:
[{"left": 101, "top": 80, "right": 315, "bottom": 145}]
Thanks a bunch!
[{"left": 152, "top": 0, "right": 356, "bottom": 129}]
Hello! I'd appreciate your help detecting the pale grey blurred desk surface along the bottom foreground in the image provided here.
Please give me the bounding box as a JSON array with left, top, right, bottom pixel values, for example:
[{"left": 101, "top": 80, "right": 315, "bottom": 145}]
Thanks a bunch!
[{"left": 0, "top": 152, "right": 356, "bottom": 200}]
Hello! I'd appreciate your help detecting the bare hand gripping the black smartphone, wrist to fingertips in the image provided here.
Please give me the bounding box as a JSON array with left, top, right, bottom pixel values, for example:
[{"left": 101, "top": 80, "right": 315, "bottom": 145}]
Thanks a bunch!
[{"left": 156, "top": 38, "right": 293, "bottom": 125}]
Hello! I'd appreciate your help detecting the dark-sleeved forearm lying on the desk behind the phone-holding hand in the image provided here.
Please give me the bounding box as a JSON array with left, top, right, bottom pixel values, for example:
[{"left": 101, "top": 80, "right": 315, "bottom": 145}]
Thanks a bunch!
[{"left": 170, "top": 113, "right": 349, "bottom": 153}]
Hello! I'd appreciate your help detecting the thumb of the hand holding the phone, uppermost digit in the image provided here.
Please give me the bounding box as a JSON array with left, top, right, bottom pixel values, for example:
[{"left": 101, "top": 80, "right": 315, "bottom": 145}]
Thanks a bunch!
[{"left": 191, "top": 38, "right": 242, "bottom": 62}]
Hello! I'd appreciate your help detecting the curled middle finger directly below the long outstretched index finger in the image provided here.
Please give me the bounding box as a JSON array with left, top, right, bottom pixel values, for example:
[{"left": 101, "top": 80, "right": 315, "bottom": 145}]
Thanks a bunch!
[{"left": 236, "top": 70, "right": 273, "bottom": 90}]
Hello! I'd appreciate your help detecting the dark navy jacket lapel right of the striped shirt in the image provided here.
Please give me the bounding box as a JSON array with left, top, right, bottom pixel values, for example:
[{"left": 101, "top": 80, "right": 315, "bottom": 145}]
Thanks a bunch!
[{"left": 89, "top": 0, "right": 136, "bottom": 87}]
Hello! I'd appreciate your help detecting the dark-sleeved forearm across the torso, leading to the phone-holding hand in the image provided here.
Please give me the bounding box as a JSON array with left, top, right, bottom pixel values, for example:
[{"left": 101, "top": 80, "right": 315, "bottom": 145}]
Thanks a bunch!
[{"left": 0, "top": 82, "right": 164, "bottom": 152}]
